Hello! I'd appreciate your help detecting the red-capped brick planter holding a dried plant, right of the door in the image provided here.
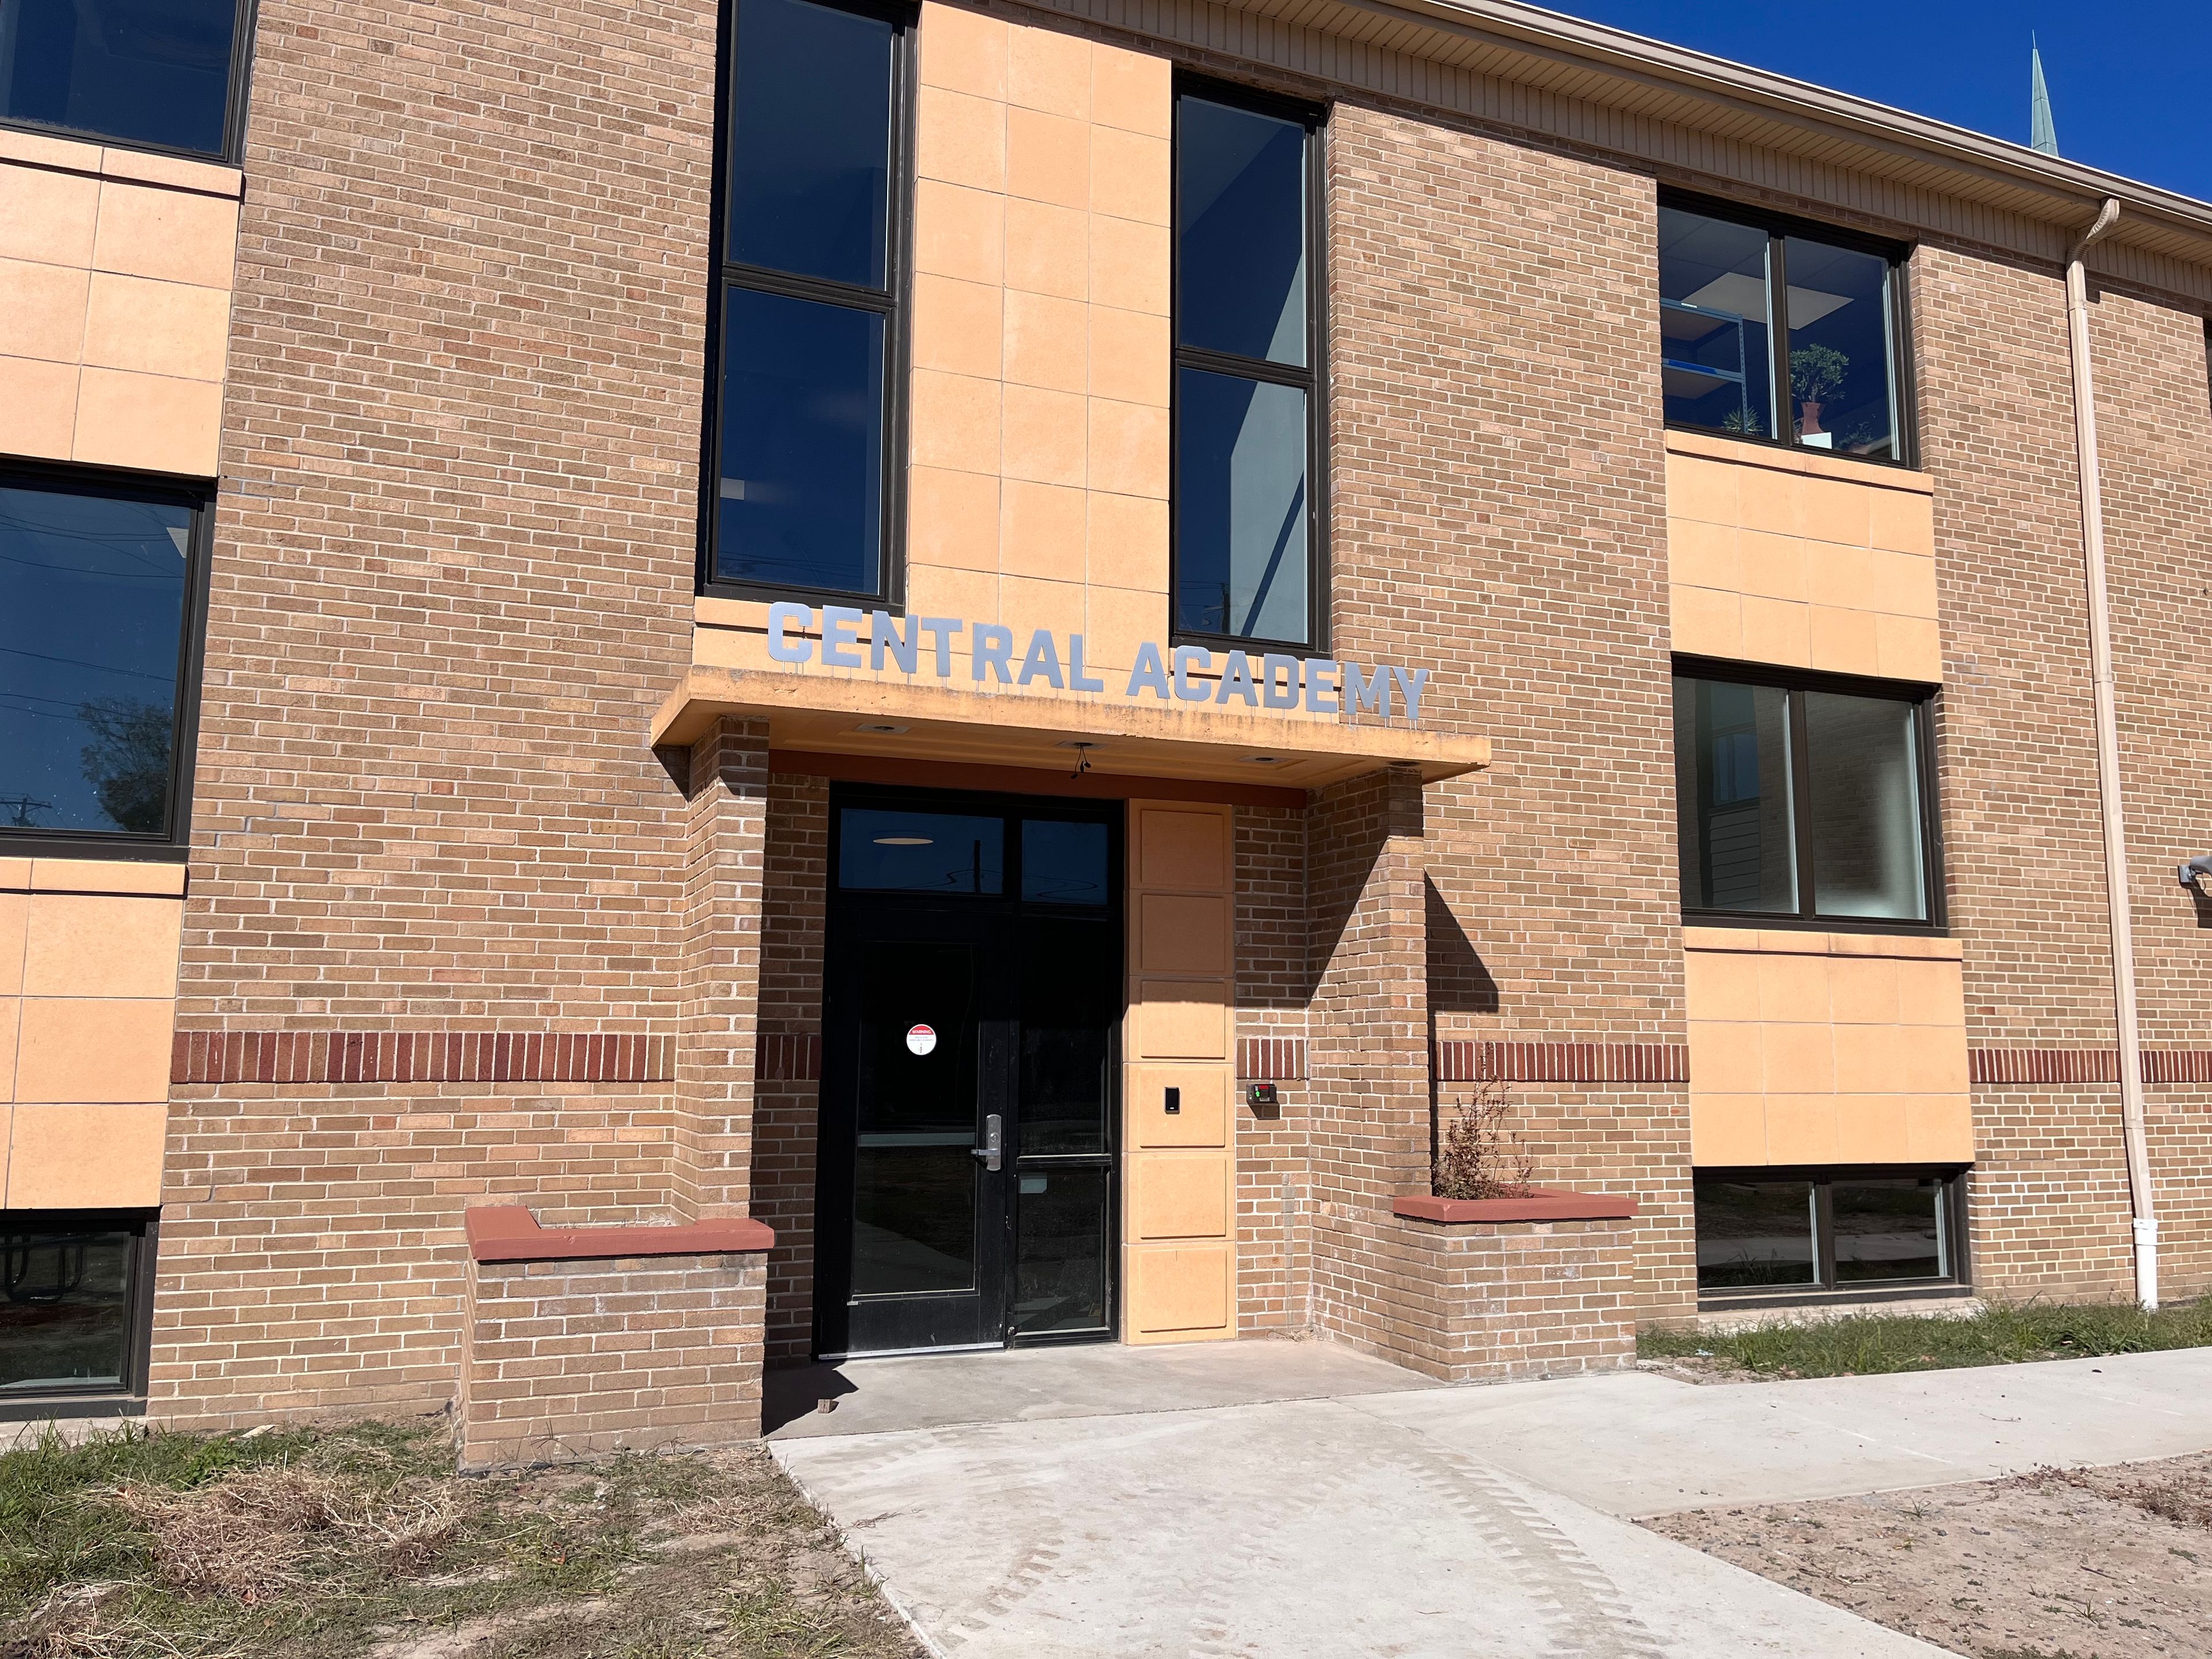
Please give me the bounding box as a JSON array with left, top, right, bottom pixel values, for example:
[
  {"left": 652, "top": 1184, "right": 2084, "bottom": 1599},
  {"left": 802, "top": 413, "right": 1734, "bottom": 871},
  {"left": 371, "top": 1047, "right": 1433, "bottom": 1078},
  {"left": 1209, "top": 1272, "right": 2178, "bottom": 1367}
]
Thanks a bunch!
[{"left": 1391, "top": 1188, "right": 1637, "bottom": 1382}]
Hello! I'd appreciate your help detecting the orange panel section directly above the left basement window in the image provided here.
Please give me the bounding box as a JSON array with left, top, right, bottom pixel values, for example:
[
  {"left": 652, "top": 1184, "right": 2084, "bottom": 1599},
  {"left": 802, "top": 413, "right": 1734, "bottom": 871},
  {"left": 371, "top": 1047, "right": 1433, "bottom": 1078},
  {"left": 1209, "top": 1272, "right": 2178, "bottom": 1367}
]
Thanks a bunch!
[{"left": 0, "top": 858, "right": 184, "bottom": 1210}]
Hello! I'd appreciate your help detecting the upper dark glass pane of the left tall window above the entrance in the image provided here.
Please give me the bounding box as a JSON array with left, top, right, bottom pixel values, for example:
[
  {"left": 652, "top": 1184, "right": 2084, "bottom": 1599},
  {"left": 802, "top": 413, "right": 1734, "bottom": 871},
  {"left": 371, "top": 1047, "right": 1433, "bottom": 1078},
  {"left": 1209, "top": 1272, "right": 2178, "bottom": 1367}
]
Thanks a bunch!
[{"left": 730, "top": 0, "right": 896, "bottom": 287}]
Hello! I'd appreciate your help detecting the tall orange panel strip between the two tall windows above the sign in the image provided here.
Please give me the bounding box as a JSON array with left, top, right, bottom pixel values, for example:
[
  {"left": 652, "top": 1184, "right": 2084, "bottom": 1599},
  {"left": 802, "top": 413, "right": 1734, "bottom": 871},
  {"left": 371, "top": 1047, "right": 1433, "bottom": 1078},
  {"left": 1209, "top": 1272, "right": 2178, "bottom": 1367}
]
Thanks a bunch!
[{"left": 907, "top": 5, "right": 1175, "bottom": 672}]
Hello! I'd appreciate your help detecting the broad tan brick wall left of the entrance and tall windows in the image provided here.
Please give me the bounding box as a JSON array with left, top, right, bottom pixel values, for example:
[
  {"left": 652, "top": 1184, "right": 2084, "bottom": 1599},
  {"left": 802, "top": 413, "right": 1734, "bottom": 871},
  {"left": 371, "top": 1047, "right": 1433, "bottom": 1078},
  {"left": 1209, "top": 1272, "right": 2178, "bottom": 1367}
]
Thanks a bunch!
[{"left": 153, "top": 0, "right": 725, "bottom": 1418}]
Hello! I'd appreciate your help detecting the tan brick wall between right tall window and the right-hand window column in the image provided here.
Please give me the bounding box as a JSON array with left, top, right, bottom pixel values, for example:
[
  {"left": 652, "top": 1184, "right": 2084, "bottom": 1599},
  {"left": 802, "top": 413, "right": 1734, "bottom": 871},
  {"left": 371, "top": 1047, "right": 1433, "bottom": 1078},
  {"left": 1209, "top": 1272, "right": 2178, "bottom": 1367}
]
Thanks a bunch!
[{"left": 1330, "top": 102, "right": 1692, "bottom": 1309}]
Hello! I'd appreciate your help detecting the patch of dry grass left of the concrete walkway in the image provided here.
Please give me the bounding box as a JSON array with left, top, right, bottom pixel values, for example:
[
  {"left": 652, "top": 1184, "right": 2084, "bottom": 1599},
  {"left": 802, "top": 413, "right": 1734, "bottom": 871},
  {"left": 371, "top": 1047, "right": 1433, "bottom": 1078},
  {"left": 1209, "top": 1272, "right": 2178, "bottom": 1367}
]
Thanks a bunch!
[{"left": 0, "top": 1420, "right": 916, "bottom": 1659}]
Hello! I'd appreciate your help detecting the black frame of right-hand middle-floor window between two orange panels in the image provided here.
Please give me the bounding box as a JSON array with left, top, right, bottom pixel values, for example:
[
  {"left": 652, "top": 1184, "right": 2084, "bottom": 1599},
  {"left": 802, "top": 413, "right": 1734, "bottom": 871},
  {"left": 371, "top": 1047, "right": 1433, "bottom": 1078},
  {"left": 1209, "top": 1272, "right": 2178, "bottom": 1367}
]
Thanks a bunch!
[{"left": 1668, "top": 657, "right": 1949, "bottom": 938}]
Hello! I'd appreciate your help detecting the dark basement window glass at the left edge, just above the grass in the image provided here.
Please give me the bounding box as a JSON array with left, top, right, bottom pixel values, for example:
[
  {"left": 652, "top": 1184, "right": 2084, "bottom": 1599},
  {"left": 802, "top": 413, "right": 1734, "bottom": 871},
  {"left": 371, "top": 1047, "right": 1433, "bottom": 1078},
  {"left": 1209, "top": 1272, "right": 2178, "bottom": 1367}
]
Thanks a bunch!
[{"left": 0, "top": 1217, "right": 135, "bottom": 1398}]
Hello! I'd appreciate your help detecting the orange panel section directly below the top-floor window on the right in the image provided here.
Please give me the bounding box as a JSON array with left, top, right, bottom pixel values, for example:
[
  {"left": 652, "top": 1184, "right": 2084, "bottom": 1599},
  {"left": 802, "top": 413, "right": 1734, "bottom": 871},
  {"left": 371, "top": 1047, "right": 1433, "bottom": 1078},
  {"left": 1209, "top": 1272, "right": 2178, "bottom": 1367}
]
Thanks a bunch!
[{"left": 1666, "top": 431, "right": 1942, "bottom": 684}]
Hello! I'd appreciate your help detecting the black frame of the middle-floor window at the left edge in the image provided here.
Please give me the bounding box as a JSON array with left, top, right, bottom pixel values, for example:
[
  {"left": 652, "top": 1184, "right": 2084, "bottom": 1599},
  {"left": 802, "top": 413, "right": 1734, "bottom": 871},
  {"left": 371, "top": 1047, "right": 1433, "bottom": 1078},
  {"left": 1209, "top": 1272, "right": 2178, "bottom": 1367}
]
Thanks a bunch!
[{"left": 0, "top": 460, "right": 214, "bottom": 865}]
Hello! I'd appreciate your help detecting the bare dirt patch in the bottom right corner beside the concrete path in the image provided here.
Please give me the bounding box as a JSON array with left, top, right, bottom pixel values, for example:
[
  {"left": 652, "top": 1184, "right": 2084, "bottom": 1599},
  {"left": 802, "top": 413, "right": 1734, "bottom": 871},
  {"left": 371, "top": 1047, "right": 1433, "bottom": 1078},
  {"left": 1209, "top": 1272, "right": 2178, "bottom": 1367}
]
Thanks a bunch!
[{"left": 1643, "top": 1453, "right": 2212, "bottom": 1659}]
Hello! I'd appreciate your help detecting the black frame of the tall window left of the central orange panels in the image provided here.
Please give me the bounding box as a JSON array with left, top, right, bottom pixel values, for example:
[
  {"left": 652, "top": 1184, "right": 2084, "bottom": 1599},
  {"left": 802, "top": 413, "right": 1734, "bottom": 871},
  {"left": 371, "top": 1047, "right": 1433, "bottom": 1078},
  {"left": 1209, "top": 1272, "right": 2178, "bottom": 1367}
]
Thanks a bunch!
[{"left": 695, "top": 0, "right": 920, "bottom": 617}]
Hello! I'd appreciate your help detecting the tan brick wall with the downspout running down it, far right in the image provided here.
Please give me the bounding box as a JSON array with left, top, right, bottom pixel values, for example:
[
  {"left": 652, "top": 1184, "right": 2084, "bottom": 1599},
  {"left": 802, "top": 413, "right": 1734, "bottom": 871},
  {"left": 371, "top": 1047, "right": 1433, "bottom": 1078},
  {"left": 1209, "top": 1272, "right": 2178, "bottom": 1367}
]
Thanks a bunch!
[{"left": 1914, "top": 245, "right": 2212, "bottom": 1296}]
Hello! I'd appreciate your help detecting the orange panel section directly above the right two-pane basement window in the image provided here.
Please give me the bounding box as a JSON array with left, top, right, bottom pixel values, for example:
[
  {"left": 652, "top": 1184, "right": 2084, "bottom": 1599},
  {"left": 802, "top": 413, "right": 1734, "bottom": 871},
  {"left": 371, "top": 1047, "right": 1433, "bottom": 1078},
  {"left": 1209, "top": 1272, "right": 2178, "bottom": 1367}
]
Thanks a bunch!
[{"left": 1683, "top": 927, "right": 1973, "bottom": 1168}]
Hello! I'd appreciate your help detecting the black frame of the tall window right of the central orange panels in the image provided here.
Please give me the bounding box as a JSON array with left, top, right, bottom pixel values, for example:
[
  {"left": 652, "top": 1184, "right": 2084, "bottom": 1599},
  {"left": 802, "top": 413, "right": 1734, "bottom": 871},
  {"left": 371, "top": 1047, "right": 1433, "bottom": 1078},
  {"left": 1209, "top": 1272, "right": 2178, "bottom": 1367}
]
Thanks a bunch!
[{"left": 1168, "top": 71, "right": 1332, "bottom": 657}]
